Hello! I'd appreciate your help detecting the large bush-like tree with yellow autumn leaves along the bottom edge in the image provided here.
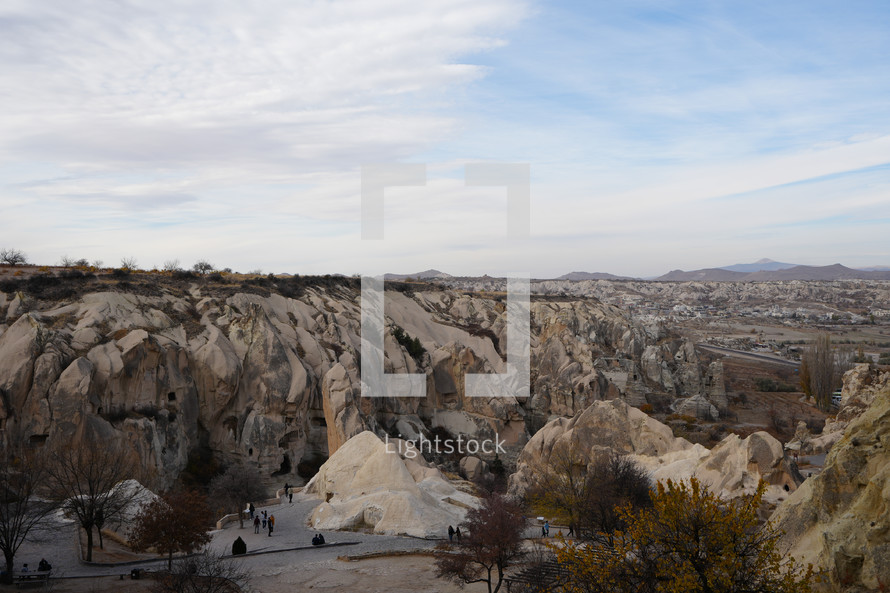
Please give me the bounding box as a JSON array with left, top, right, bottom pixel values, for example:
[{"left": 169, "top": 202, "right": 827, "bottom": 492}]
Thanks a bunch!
[{"left": 555, "top": 478, "right": 812, "bottom": 593}]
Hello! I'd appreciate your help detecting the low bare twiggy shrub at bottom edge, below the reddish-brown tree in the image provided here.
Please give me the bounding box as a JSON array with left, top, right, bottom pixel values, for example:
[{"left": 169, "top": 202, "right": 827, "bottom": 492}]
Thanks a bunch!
[{"left": 153, "top": 551, "right": 250, "bottom": 593}]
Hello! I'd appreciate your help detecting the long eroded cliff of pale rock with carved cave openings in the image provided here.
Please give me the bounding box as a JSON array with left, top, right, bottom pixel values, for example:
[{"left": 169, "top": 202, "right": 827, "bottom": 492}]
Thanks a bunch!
[{"left": 0, "top": 273, "right": 722, "bottom": 483}]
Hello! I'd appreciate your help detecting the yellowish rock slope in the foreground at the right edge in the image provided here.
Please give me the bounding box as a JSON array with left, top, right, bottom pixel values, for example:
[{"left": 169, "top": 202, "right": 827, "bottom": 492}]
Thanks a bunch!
[{"left": 772, "top": 365, "right": 890, "bottom": 592}]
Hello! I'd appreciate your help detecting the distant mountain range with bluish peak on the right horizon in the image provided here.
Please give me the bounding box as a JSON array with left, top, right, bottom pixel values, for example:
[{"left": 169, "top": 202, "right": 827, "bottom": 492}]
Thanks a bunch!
[{"left": 656, "top": 264, "right": 890, "bottom": 282}]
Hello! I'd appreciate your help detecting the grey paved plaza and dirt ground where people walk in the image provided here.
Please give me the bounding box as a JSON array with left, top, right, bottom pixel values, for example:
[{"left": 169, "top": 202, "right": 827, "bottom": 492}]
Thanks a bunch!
[{"left": 0, "top": 494, "right": 487, "bottom": 593}]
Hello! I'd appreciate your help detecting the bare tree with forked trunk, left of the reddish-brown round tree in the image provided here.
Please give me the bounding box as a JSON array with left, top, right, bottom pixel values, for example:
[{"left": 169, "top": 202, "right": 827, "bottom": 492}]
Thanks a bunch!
[{"left": 47, "top": 440, "right": 138, "bottom": 561}]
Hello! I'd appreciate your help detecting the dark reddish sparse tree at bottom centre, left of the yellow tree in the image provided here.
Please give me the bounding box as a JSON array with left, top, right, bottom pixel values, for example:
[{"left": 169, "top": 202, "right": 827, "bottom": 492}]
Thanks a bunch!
[{"left": 436, "top": 493, "right": 528, "bottom": 593}]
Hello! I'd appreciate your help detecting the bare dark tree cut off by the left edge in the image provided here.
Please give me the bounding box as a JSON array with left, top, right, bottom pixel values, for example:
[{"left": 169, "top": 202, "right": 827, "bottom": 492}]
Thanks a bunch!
[{"left": 0, "top": 440, "right": 58, "bottom": 581}]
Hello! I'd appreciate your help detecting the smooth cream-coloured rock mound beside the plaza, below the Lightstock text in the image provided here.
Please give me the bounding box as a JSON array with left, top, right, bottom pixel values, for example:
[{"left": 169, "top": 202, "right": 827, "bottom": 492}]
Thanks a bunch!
[{"left": 304, "top": 431, "right": 475, "bottom": 538}]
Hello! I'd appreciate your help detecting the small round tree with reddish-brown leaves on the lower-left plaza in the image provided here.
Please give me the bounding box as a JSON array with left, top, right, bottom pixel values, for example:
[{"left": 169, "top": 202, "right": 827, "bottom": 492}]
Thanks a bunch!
[{"left": 130, "top": 490, "right": 211, "bottom": 569}]
